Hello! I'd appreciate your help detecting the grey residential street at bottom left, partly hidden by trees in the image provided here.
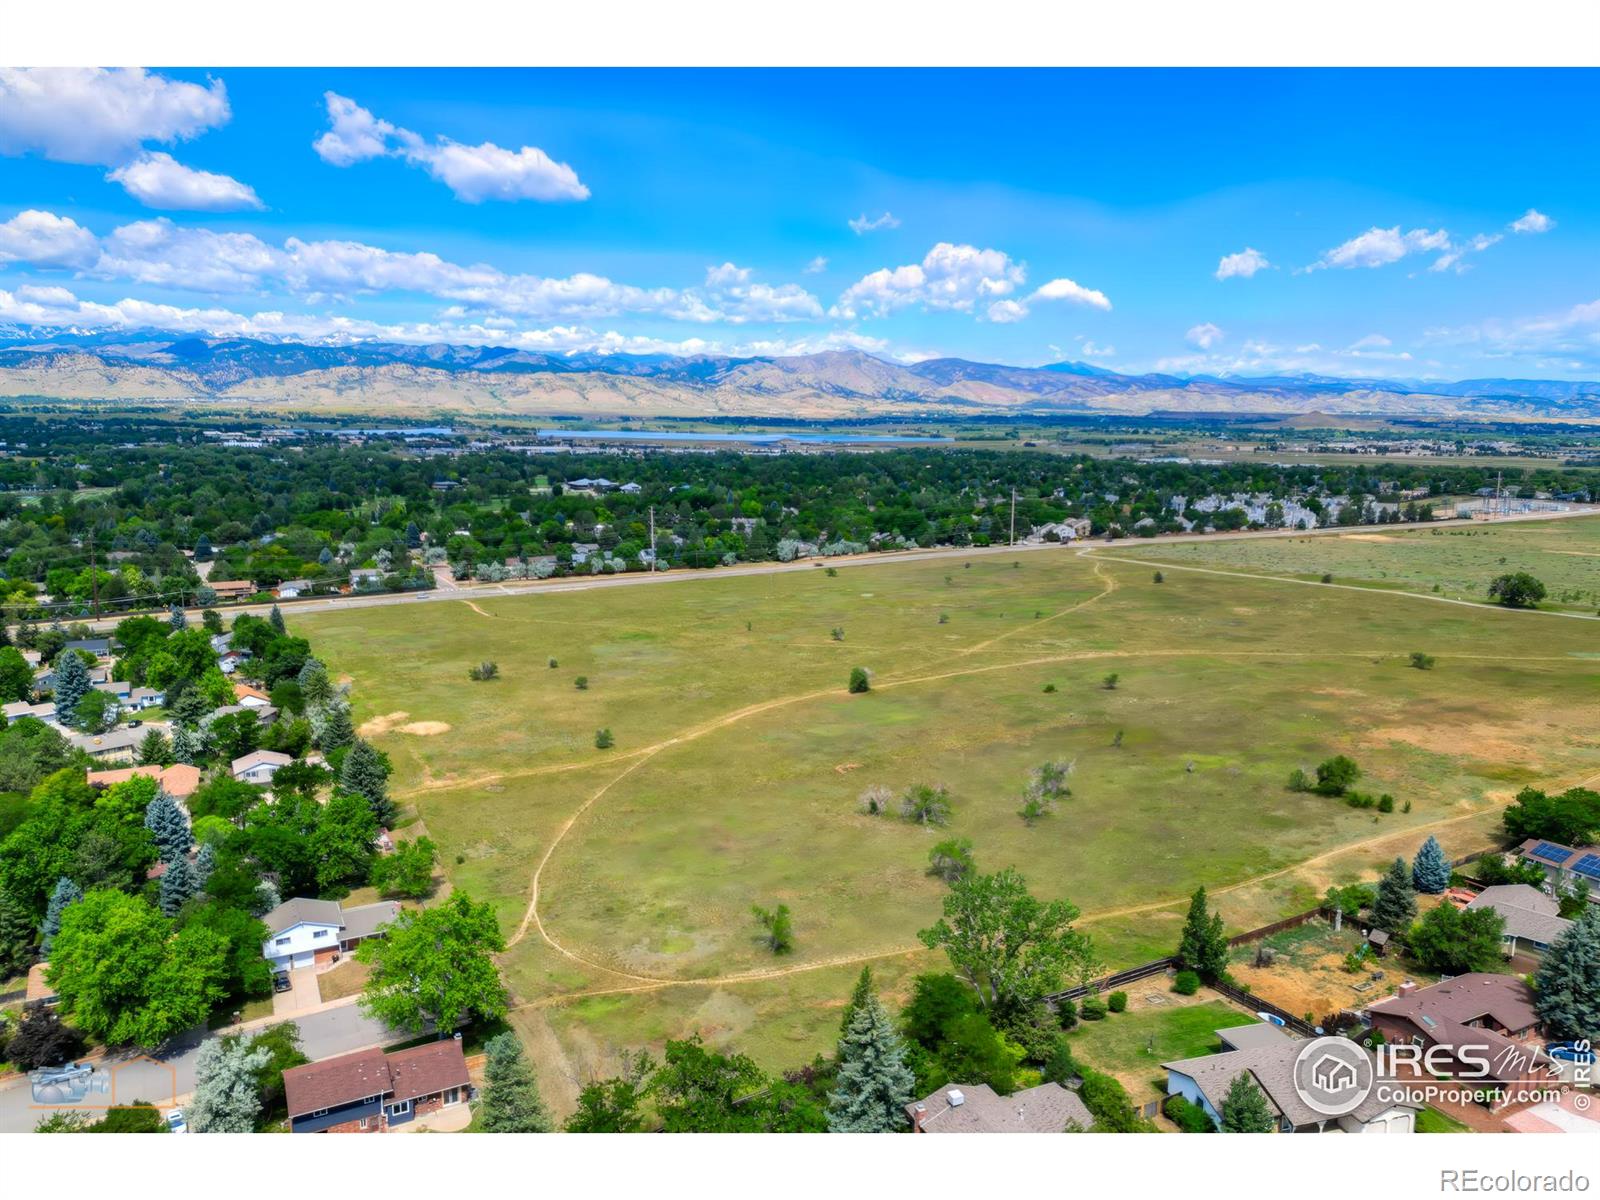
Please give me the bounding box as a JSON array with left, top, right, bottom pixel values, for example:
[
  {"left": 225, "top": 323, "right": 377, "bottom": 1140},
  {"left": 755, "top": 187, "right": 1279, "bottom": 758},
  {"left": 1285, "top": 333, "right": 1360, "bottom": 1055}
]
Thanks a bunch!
[{"left": 0, "top": 1005, "right": 405, "bottom": 1133}]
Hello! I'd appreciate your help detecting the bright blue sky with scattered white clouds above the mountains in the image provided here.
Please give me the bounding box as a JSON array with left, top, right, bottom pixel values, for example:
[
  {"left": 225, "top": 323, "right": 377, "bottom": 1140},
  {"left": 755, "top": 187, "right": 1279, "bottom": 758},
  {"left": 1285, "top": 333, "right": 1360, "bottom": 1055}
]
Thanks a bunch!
[{"left": 0, "top": 69, "right": 1600, "bottom": 378}]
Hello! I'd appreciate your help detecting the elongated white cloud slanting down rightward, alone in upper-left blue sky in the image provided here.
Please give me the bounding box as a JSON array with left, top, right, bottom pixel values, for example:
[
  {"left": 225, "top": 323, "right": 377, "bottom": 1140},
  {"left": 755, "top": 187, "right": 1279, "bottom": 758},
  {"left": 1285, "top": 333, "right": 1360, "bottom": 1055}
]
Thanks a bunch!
[{"left": 312, "top": 91, "right": 589, "bottom": 205}]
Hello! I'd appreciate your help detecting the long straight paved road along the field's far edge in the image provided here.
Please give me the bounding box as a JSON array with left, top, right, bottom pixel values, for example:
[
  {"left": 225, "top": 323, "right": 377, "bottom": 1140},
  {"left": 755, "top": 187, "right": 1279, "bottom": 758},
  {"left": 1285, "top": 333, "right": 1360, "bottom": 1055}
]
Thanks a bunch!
[{"left": 72, "top": 504, "right": 1600, "bottom": 632}]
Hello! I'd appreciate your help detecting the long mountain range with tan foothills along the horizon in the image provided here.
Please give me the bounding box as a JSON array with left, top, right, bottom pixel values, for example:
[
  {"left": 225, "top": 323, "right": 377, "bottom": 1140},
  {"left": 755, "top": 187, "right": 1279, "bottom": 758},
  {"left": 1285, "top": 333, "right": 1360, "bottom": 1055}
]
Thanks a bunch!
[{"left": 0, "top": 330, "right": 1600, "bottom": 421}]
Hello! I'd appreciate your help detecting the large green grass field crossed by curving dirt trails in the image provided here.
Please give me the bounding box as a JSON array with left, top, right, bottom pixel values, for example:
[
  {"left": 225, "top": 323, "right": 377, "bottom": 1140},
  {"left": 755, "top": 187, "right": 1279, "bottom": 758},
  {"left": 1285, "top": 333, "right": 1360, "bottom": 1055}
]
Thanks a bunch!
[{"left": 290, "top": 522, "right": 1600, "bottom": 1109}]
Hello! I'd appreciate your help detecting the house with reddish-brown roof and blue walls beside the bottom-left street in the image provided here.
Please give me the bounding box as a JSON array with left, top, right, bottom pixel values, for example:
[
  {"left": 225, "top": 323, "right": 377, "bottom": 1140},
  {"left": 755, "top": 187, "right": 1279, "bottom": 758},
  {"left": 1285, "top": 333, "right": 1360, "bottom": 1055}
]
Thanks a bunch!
[{"left": 283, "top": 1038, "right": 472, "bottom": 1133}]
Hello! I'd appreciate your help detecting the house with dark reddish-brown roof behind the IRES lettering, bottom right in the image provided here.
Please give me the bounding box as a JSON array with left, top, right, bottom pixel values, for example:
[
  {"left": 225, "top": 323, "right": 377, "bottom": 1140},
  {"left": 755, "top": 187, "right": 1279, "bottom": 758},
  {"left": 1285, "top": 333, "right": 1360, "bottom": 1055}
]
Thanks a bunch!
[{"left": 1366, "top": 971, "right": 1550, "bottom": 1113}]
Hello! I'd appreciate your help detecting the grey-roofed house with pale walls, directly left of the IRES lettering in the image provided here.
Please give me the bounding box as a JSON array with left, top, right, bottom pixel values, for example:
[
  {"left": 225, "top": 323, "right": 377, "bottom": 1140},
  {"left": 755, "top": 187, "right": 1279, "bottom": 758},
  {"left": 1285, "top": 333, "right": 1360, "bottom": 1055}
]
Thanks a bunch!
[{"left": 1162, "top": 1043, "right": 1422, "bottom": 1133}]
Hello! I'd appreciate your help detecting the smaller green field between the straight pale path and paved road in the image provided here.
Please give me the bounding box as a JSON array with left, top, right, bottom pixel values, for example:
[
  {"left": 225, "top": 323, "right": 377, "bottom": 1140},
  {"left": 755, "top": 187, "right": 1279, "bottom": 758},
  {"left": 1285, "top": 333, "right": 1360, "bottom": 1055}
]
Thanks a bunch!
[{"left": 1112, "top": 517, "right": 1600, "bottom": 613}]
